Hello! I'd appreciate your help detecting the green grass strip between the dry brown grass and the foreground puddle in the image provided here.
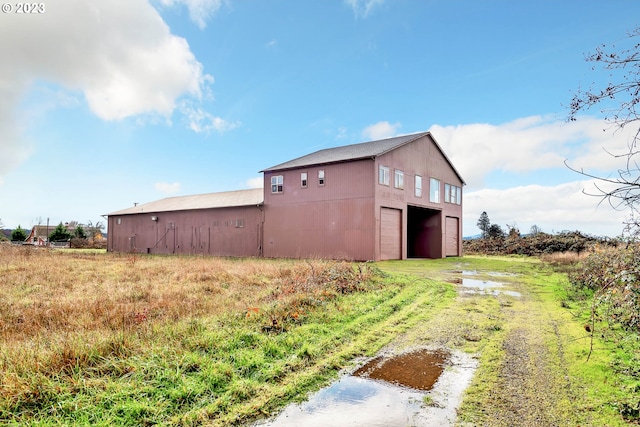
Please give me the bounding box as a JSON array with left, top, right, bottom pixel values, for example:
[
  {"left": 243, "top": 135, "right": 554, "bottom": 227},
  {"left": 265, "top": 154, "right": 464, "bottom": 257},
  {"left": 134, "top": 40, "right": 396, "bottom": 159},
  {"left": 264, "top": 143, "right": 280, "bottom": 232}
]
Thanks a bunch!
[{"left": 0, "top": 258, "right": 453, "bottom": 426}]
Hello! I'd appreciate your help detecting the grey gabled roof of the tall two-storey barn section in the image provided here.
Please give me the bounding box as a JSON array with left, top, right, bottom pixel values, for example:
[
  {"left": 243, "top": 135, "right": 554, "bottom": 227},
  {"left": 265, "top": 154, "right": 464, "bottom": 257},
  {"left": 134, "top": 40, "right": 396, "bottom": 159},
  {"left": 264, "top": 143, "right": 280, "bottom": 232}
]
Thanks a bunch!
[{"left": 260, "top": 132, "right": 465, "bottom": 184}]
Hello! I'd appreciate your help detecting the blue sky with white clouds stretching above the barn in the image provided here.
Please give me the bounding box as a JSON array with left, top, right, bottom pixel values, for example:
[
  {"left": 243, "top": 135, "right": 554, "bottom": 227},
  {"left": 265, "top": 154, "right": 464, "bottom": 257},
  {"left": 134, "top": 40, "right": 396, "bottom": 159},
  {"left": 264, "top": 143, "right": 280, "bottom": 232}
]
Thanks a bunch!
[{"left": 0, "top": 0, "right": 640, "bottom": 236}]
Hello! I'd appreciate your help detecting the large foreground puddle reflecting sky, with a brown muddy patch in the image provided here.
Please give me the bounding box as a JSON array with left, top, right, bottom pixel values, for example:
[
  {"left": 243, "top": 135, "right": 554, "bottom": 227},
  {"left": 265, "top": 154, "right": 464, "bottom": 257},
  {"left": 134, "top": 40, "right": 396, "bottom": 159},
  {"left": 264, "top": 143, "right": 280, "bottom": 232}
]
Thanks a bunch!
[{"left": 254, "top": 350, "right": 477, "bottom": 427}]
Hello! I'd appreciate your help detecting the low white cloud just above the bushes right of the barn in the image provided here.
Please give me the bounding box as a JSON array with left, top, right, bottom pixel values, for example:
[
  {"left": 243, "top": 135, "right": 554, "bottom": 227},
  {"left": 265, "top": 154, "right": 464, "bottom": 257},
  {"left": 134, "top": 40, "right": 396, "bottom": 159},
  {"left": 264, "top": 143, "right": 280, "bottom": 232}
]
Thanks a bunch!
[{"left": 463, "top": 180, "right": 628, "bottom": 236}]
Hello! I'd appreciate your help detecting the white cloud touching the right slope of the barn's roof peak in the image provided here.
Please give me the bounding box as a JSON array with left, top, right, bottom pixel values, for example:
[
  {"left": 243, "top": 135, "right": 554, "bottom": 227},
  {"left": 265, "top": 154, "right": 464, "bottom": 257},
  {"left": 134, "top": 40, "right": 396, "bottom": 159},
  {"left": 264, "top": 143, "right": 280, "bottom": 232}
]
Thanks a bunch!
[{"left": 430, "top": 116, "right": 632, "bottom": 188}]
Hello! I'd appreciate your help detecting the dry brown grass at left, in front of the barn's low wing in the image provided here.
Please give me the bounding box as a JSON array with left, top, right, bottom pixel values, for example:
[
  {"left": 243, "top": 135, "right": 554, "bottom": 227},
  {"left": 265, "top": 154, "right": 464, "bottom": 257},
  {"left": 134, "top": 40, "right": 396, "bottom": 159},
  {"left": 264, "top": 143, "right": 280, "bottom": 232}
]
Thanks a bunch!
[{"left": 0, "top": 245, "right": 372, "bottom": 382}]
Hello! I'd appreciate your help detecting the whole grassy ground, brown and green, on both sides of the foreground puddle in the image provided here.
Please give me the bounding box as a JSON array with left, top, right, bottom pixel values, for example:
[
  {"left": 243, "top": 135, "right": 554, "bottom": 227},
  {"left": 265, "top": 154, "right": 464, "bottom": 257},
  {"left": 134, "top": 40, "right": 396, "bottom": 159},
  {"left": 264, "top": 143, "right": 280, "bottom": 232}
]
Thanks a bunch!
[{"left": 0, "top": 245, "right": 640, "bottom": 426}]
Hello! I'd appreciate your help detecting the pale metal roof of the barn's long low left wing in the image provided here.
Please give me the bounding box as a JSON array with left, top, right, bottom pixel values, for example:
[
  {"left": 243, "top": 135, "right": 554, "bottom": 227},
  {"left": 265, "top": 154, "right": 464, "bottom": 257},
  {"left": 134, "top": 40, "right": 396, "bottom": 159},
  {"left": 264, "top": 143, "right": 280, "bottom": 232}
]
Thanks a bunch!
[{"left": 107, "top": 188, "right": 264, "bottom": 216}]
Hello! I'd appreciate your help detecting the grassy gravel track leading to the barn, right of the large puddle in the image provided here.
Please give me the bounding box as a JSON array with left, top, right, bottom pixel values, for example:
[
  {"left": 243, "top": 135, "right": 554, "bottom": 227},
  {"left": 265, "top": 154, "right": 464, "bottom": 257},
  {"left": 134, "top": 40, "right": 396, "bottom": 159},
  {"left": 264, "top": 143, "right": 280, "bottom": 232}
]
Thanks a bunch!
[{"left": 380, "top": 262, "right": 589, "bottom": 426}]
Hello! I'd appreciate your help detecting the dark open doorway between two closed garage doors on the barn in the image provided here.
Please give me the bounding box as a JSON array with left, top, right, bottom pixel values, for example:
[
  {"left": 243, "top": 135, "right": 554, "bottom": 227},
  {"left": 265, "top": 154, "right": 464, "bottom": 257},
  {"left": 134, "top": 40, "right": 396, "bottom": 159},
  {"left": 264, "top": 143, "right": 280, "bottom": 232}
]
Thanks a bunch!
[{"left": 407, "top": 206, "right": 442, "bottom": 258}]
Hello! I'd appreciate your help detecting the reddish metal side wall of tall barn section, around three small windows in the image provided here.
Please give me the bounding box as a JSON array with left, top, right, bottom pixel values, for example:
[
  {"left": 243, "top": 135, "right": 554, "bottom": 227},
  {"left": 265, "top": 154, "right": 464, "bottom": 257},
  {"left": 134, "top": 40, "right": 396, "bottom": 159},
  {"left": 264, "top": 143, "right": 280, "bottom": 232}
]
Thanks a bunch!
[{"left": 264, "top": 160, "right": 376, "bottom": 260}]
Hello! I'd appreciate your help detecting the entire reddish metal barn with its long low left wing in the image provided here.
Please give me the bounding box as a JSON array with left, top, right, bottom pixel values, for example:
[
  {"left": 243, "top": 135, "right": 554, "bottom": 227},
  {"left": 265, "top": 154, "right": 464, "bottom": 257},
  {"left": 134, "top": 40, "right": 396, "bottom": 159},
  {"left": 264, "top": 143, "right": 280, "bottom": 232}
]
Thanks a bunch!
[{"left": 107, "top": 132, "right": 465, "bottom": 260}]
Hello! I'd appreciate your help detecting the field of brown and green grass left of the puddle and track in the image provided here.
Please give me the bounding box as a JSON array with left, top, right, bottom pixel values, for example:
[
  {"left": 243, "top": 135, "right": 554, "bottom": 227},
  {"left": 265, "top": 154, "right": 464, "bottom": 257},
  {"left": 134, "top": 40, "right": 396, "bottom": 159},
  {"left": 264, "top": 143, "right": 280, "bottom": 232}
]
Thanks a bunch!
[{"left": 0, "top": 246, "right": 453, "bottom": 426}]
